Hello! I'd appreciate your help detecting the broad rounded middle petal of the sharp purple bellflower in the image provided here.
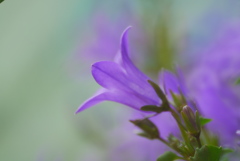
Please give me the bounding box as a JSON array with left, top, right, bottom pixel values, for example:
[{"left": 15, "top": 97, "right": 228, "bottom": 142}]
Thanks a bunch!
[{"left": 92, "top": 61, "right": 160, "bottom": 105}]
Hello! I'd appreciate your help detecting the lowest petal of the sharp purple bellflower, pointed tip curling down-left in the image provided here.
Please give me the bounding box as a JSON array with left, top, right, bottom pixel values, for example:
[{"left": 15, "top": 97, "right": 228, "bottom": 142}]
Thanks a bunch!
[{"left": 76, "top": 89, "right": 158, "bottom": 113}]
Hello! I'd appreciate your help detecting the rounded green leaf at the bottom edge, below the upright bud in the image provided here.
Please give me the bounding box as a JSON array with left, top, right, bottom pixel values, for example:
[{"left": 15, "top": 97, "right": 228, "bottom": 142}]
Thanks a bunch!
[{"left": 191, "top": 145, "right": 223, "bottom": 161}]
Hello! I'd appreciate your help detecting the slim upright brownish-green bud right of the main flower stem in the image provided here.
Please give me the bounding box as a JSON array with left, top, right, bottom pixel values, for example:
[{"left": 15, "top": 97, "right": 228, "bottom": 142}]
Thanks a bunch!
[{"left": 181, "top": 105, "right": 200, "bottom": 137}]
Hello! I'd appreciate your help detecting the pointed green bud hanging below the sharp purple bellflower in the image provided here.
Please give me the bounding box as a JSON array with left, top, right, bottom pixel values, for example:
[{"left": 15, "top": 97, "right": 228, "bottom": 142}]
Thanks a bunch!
[{"left": 130, "top": 118, "right": 159, "bottom": 139}]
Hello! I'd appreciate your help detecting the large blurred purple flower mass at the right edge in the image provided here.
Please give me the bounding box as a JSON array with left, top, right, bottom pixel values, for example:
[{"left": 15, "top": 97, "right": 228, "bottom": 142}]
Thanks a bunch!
[{"left": 187, "top": 24, "right": 240, "bottom": 145}]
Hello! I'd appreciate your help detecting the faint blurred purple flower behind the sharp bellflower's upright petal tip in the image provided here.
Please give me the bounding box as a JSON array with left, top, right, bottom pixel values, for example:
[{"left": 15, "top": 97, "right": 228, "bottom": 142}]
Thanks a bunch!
[{"left": 75, "top": 12, "right": 147, "bottom": 62}]
